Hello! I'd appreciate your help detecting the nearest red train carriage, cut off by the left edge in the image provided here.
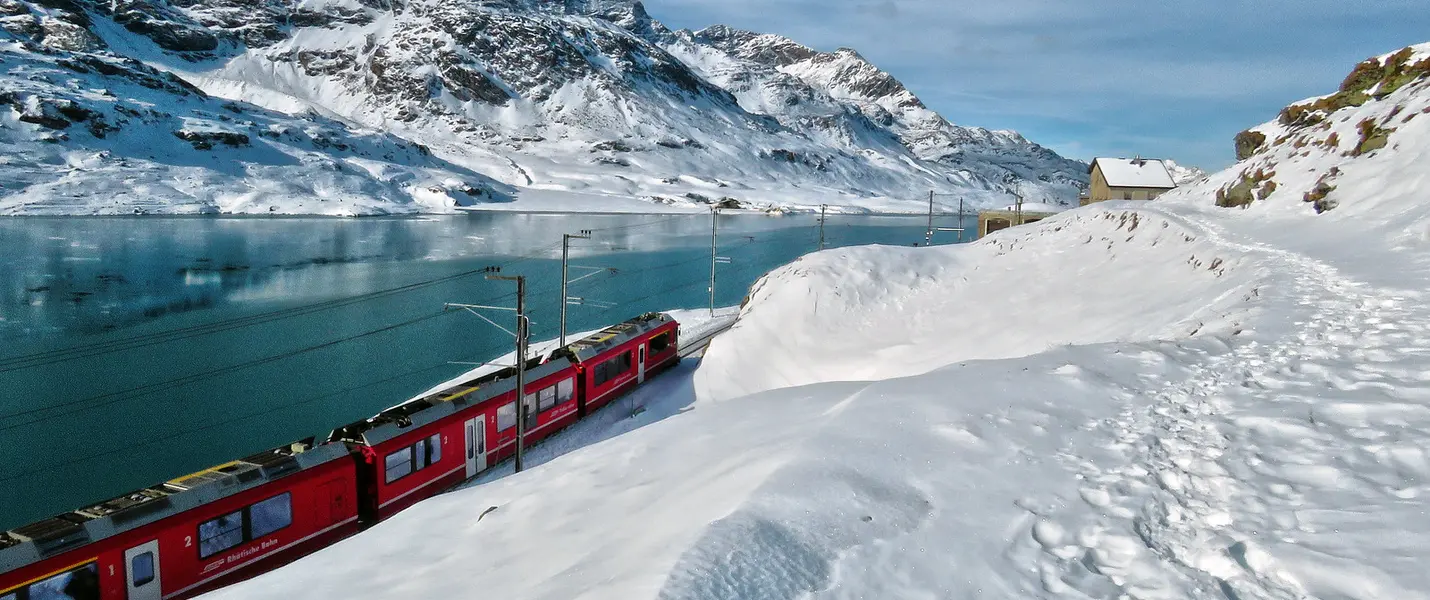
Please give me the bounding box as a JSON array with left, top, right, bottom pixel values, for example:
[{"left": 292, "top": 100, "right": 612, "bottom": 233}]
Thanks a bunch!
[{"left": 0, "top": 440, "right": 358, "bottom": 600}]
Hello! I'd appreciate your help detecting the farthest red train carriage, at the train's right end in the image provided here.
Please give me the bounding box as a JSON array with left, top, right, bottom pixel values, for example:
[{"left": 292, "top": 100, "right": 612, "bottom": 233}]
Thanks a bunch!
[{"left": 565, "top": 313, "right": 681, "bottom": 416}]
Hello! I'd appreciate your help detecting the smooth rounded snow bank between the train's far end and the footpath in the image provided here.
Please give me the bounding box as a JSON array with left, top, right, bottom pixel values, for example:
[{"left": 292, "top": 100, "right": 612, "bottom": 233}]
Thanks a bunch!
[{"left": 696, "top": 204, "right": 1257, "bottom": 399}]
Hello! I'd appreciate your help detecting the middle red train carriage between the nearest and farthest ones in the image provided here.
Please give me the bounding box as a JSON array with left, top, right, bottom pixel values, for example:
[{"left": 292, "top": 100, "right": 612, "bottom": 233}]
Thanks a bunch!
[{"left": 330, "top": 357, "right": 576, "bottom": 521}]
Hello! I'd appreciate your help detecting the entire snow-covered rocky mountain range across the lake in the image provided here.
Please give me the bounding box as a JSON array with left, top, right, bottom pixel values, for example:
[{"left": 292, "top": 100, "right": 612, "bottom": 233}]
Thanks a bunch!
[{"left": 0, "top": 0, "right": 1087, "bottom": 213}]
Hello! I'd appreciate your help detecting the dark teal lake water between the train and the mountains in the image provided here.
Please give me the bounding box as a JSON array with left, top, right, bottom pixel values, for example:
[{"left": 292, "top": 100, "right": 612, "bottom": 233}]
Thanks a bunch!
[{"left": 0, "top": 213, "right": 966, "bottom": 529}]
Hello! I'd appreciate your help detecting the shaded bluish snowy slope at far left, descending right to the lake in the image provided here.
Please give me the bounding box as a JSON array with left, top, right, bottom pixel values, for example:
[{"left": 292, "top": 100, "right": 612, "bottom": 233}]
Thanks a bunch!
[{"left": 0, "top": 0, "right": 509, "bottom": 216}]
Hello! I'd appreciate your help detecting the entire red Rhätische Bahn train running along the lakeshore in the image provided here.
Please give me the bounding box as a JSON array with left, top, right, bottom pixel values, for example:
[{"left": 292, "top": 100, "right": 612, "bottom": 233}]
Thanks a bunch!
[{"left": 0, "top": 313, "right": 679, "bottom": 600}]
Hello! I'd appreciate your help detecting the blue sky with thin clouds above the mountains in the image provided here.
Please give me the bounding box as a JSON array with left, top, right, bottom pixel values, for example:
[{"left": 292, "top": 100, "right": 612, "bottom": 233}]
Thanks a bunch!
[{"left": 646, "top": 0, "right": 1430, "bottom": 170}]
